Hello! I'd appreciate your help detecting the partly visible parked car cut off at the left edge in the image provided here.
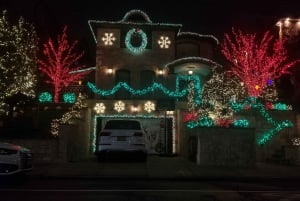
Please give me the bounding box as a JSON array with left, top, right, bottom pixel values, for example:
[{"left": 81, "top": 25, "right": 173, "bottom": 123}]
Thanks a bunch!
[{"left": 0, "top": 142, "right": 32, "bottom": 176}]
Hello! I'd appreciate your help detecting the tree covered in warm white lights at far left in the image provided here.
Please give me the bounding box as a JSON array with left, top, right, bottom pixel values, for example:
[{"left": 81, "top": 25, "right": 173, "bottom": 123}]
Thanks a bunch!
[{"left": 0, "top": 10, "right": 38, "bottom": 115}]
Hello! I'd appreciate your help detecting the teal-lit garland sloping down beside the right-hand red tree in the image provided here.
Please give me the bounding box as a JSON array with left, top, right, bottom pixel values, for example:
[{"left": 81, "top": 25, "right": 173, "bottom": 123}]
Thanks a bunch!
[{"left": 230, "top": 97, "right": 293, "bottom": 145}]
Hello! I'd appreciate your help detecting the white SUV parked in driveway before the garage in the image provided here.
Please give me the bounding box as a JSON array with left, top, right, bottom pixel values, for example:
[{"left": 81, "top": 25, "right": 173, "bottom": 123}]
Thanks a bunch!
[{"left": 95, "top": 119, "right": 147, "bottom": 161}]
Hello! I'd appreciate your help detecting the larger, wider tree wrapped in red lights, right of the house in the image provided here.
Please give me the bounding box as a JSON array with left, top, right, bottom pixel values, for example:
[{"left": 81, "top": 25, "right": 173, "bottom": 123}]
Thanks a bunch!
[{"left": 221, "top": 28, "right": 299, "bottom": 97}]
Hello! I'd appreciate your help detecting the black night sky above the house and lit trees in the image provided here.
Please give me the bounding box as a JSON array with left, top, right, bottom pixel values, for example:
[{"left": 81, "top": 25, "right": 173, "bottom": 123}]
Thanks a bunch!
[{"left": 0, "top": 0, "right": 300, "bottom": 63}]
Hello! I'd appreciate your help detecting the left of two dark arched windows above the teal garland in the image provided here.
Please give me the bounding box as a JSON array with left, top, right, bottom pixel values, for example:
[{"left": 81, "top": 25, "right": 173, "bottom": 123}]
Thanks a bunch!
[{"left": 115, "top": 69, "right": 130, "bottom": 99}]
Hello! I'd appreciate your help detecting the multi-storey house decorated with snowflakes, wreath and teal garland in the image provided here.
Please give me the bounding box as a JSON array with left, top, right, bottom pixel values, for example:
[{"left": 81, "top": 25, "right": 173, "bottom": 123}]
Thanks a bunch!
[{"left": 88, "top": 10, "right": 218, "bottom": 154}]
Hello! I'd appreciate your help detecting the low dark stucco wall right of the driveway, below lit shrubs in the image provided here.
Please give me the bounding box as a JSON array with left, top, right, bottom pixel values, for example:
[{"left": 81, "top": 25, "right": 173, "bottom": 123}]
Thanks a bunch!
[{"left": 190, "top": 128, "right": 256, "bottom": 167}]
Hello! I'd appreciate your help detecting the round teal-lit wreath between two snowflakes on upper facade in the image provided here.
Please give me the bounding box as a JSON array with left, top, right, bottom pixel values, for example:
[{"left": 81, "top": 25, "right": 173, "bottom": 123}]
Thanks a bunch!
[{"left": 125, "top": 28, "right": 148, "bottom": 54}]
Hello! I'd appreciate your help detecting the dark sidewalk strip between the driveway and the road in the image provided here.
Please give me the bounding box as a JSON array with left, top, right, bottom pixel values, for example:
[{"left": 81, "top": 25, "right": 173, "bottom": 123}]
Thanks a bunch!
[{"left": 29, "top": 155, "right": 300, "bottom": 180}]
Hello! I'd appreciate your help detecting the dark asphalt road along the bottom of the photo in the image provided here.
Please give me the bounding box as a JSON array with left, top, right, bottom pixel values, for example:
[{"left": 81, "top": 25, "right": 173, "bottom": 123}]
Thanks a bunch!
[{"left": 0, "top": 177, "right": 300, "bottom": 201}]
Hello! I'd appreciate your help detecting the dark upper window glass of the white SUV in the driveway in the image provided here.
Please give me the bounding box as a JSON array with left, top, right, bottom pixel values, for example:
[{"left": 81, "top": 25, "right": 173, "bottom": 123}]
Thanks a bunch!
[{"left": 104, "top": 120, "right": 141, "bottom": 130}]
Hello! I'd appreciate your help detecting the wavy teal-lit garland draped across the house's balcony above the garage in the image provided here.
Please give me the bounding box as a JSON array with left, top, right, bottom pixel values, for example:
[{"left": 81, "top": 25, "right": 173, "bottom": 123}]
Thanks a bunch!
[{"left": 87, "top": 75, "right": 201, "bottom": 106}]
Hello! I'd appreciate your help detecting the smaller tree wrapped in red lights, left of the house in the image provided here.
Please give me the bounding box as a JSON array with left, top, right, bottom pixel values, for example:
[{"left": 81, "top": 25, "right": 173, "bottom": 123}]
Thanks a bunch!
[{"left": 38, "top": 26, "right": 91, "bottom": 103}]
